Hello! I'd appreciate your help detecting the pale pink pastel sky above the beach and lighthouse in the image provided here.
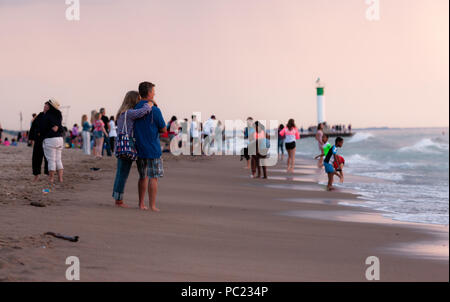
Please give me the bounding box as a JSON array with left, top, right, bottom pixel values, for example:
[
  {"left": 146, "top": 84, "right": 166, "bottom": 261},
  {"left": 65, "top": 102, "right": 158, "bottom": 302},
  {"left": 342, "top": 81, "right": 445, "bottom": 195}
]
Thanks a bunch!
[{"left": 0, "top": 0, "right": 449, "bottom": 129}]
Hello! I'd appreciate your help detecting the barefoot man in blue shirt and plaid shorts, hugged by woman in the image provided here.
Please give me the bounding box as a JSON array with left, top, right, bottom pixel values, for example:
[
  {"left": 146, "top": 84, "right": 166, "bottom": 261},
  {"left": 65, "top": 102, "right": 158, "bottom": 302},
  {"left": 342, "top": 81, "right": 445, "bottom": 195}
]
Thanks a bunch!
[{"left": 134, "top": 82, "right": 167, "bottom": 212}]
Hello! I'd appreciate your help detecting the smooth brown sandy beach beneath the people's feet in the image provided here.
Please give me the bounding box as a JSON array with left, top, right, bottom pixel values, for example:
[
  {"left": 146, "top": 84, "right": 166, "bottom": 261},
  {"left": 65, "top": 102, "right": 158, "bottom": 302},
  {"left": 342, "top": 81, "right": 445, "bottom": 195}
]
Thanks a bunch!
[{"left": 0, "top": 144, "right": 449, "bottom": 281}]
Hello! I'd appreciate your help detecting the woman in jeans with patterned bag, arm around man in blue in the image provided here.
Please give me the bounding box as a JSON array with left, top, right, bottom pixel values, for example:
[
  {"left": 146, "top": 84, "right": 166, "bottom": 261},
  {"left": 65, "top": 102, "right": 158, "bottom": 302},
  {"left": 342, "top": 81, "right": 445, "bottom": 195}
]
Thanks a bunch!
[{"left": 112, "top": 91, "right": 152, "bottom": 208}]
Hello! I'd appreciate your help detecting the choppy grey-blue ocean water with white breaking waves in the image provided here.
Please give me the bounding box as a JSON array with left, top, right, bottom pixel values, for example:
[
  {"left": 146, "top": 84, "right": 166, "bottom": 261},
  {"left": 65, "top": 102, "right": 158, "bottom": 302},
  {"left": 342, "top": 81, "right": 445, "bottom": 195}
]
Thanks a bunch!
[{"left": 297, "top": 128, "right": 449, "bottom": 225}]
